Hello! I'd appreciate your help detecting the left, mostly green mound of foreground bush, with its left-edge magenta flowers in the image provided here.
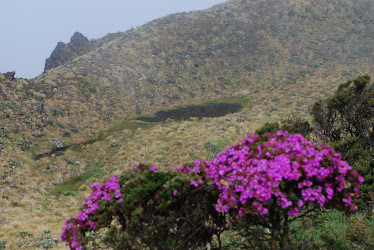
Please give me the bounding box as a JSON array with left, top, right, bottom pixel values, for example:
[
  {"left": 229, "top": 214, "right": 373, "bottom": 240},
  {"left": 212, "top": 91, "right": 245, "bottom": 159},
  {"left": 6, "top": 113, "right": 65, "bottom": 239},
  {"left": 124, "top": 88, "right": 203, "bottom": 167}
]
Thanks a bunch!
[{"left": 61, "top": 164, "right": 225, "bottom": 249}]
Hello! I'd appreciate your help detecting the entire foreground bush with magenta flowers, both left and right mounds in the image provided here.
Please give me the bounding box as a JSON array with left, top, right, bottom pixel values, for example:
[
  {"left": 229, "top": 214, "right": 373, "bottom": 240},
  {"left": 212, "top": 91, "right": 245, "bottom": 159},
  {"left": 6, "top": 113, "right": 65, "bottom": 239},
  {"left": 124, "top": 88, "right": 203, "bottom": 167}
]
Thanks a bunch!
[{"left": 62, "top": 131, "right": 363, "bottom": 249}]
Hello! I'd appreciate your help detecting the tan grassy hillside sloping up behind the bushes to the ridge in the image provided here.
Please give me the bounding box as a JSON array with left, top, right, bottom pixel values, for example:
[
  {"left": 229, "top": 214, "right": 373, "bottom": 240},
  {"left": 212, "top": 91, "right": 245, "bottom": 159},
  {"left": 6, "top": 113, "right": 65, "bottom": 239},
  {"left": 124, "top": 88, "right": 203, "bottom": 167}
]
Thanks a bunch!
[{"left": 0, "top": 0, "right": 374, "bottom": 247}]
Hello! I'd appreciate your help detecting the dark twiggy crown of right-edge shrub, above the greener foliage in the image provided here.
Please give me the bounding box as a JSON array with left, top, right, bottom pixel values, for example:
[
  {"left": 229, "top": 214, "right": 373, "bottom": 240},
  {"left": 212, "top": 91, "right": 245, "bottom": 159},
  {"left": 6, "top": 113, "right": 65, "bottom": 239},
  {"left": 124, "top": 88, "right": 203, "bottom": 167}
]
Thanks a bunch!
[{"left": 311, "top": 75, "right": 374, "bottom": 147}]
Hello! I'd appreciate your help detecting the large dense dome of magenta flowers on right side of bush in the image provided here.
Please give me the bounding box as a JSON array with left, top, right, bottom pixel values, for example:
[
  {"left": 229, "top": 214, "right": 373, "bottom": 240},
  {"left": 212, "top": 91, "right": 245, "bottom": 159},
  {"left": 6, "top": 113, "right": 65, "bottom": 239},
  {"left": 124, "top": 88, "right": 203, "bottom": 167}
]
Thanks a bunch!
[{"left": 200, "top": 131, "right": 363, "bottom": 217}]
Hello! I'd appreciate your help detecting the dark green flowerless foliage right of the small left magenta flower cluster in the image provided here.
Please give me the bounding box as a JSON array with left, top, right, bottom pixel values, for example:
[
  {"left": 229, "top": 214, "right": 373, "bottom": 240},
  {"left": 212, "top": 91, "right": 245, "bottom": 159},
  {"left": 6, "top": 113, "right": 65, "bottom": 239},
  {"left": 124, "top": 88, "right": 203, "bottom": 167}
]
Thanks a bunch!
[{"left": 87, "top": 165, "right": 225, "bottom": 249}]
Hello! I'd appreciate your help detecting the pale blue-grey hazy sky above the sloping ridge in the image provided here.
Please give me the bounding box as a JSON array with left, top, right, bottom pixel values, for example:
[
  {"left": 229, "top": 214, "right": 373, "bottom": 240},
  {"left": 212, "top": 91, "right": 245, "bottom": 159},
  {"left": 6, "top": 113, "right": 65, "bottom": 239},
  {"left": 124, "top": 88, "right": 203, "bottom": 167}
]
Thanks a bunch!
[{"left": 0, "top": 0, "right": 225, "bottom": 78}]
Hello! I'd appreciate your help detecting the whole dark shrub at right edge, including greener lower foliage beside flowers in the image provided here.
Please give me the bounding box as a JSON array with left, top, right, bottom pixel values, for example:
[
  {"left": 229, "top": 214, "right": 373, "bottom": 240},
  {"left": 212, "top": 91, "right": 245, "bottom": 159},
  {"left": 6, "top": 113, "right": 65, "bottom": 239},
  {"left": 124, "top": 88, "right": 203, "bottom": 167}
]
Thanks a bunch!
[{"left": 311, "top": 75, "right": 374, "bottom": 208}]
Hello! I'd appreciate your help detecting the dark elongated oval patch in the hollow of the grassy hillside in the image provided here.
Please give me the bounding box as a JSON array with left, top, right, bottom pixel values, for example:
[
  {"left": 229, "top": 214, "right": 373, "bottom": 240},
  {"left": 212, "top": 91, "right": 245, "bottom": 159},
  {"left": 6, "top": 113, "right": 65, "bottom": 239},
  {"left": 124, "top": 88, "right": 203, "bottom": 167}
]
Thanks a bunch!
[{"left": 137, "top": 103, "right": 243, "bottom": 122}]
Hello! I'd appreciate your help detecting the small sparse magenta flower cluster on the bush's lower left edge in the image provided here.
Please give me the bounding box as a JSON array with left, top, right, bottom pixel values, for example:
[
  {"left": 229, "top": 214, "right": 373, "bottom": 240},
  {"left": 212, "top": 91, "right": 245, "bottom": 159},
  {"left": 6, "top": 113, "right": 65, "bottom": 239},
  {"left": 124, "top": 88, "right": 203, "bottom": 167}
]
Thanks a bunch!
[{"left": 61, "top": 175, "right": 123, "bottom": 250}]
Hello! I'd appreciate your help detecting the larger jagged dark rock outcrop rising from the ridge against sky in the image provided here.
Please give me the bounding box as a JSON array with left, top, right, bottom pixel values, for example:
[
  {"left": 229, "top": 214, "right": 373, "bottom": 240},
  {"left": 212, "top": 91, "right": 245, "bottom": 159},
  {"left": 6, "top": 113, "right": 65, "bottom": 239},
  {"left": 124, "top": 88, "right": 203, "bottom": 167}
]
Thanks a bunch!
[{"left": 44, "top": 32, "right": 91, "bottom": 73}]
